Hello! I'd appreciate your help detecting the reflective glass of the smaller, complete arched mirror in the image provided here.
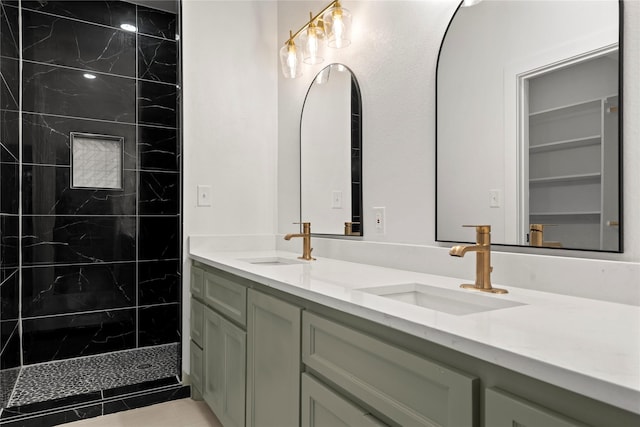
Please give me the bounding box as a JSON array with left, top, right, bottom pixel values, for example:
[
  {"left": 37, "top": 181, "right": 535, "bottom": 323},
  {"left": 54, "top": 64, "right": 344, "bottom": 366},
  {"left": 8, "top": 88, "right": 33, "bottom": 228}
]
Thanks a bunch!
[{"left": 300, "top": 64, "right": 362, "bottom": 236}]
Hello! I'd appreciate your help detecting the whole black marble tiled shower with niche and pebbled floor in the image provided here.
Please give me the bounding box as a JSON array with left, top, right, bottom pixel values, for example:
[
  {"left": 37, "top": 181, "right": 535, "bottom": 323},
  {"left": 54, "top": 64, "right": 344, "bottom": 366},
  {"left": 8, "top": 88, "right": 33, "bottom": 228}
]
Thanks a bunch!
[{"left": 0, "top": 0, "right": 188, "bottom": 425}]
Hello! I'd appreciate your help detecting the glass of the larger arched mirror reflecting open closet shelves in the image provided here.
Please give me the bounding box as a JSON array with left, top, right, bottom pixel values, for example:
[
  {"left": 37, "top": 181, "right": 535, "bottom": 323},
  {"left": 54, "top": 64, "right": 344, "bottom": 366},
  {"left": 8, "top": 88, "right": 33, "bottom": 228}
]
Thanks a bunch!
[{"left": 436, "top": 0, "right": 622, "bottom": 252}]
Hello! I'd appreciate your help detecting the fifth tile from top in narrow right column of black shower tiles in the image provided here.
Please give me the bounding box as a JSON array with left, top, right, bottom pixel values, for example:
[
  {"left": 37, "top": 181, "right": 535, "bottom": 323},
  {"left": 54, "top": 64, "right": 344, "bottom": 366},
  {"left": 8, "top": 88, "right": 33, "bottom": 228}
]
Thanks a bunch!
[{"left": 138, "top": 172, "right": 180, "bottom": 215}]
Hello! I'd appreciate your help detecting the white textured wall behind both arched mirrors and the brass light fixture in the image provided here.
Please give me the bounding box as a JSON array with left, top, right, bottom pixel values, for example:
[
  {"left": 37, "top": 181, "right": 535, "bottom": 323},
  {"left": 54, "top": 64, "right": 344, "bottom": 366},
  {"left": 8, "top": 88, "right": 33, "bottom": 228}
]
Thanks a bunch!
[{"left": 278, "top": 0, "right": 640, "bottom": 262}]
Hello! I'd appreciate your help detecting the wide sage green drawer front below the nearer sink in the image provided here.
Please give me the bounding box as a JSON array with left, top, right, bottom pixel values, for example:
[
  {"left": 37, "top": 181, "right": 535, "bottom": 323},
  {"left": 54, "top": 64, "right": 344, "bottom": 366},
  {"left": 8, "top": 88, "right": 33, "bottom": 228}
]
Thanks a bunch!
[{"left": 302, "top": 312, "right": 478, "bottom": 427}]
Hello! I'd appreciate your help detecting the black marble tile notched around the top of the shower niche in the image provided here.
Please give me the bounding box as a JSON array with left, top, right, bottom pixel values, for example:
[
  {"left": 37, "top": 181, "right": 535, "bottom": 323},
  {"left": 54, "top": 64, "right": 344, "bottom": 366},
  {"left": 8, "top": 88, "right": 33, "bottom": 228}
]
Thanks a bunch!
[{"left": 22, "top": 113, "right": 136, "bottom": 169}]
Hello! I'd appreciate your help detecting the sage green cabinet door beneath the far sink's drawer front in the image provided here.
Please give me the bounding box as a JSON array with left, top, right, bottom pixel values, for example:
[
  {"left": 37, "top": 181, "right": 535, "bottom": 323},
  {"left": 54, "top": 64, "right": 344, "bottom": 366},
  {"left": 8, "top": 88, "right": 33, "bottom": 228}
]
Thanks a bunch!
[{"left": 202, "top": 308, "right": 246, "bottom": 427}]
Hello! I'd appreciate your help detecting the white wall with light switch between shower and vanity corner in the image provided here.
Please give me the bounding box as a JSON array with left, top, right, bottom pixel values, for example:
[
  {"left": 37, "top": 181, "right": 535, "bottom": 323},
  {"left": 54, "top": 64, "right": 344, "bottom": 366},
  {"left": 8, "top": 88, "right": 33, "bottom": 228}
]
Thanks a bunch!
[{"left": 182, "top": 0, "right": 279, "bottom": 372}]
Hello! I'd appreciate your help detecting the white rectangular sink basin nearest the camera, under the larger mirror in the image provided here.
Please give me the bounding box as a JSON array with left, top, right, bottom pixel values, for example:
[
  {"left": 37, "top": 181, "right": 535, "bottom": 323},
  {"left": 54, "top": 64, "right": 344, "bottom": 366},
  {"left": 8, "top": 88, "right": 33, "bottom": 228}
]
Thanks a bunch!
[{"left": 358, "top": 283, "right": 524, "bottom": 315}]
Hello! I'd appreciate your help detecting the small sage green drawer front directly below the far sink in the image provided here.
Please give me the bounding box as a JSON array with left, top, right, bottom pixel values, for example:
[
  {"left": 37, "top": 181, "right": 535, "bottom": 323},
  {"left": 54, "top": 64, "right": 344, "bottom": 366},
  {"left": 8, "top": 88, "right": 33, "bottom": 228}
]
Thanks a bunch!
[{"left": 204, "top": 271, "right": 247, "bottom": 326}]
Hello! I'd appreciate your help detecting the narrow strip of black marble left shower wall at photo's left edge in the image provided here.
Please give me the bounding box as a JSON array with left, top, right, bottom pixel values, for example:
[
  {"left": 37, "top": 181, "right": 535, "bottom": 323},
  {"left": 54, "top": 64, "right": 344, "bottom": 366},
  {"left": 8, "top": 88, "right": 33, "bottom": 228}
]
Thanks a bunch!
[{"left": 0, "top": 1, "right": 20, "bottom": 407}]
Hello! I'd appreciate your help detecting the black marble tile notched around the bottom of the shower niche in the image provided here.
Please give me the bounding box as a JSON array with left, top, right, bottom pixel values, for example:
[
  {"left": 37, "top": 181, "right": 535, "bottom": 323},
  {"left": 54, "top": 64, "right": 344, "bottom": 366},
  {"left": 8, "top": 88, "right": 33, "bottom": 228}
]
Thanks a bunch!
[{"left": 22, "top": 165, "right": 136, "bottom": 215}]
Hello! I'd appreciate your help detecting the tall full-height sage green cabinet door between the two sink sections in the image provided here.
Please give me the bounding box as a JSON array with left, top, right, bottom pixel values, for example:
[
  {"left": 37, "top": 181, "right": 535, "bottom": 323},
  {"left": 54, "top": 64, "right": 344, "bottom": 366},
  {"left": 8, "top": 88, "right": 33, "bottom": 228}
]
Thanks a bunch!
[{"left": 247, "top": 289, "right": 301, "bottom": 426}]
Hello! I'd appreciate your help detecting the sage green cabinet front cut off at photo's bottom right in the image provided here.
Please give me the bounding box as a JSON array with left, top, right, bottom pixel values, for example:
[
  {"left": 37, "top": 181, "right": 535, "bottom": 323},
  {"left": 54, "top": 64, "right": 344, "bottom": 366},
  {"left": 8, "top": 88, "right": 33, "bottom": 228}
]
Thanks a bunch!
[{"left": 484, "top": 389, "right": 585, "bottom": 427}]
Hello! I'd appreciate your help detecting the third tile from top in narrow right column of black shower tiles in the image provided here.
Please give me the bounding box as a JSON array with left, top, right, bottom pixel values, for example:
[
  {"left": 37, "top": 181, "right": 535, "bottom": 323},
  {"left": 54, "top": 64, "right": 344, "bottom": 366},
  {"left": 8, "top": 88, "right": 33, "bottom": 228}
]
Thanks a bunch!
[{"left": 138, "top": 81, "right": 177, "bottom": 127}]
